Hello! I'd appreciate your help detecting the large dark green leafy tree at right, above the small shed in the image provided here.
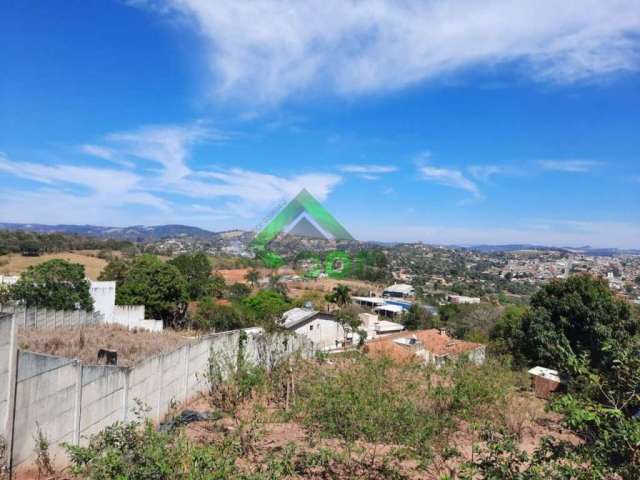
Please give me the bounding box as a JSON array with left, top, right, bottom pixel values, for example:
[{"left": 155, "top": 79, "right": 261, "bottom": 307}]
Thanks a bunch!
[{"left": 520, "top": 275, "right": 640, "bottom": 372}]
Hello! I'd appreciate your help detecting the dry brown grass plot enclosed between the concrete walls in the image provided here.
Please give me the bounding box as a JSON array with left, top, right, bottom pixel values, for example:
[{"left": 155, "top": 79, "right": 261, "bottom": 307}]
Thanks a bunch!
[{"left": 18, "top": 325, "right": 189, "bottom": 367}]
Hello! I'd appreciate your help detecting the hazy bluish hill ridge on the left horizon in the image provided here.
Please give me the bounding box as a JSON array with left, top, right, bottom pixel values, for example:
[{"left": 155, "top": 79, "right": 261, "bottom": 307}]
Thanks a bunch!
[{"left": 0, "top": 223, "right": 218, "bottom": 243}]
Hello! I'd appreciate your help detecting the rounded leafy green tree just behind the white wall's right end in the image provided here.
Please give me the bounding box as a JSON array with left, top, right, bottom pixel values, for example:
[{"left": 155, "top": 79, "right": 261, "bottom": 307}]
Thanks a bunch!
[{"left": 116, "top": 254, "right": 188, "bottom": 325}]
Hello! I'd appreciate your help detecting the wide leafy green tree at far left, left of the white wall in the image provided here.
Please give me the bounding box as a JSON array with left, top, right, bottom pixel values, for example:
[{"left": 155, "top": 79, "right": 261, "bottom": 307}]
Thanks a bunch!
[{"left": 11, "top": 259, "right": 93, "bottom": 312}]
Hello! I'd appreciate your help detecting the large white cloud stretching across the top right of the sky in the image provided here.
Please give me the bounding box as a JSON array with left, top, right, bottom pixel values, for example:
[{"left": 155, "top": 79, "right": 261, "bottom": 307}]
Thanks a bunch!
[{"left": 136, "top": 0, "right": 640, "bottom": 103}]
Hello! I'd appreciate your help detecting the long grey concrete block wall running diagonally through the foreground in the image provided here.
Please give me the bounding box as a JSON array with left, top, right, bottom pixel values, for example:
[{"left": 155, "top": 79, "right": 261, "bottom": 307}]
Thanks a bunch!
[{"left": 0, "top": 317, "right": 314, "bottom": 468}]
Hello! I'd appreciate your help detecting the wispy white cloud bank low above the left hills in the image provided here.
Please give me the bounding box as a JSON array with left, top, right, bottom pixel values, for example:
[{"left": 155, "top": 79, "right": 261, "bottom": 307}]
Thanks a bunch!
[{"left": 0, "top": 123, "right": 342, "bottom": 223}]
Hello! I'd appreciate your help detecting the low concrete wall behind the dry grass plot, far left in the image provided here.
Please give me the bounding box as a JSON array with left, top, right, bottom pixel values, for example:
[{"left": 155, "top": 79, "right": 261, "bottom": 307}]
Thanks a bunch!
[{"left": 0, "top": 305, "right": 104, "bottom": 329}]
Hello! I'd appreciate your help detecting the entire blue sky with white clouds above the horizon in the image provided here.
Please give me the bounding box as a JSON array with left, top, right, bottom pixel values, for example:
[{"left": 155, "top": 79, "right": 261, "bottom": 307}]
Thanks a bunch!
[{"left": 0, "top": 0, "right": 640, "bottom": 248}]
